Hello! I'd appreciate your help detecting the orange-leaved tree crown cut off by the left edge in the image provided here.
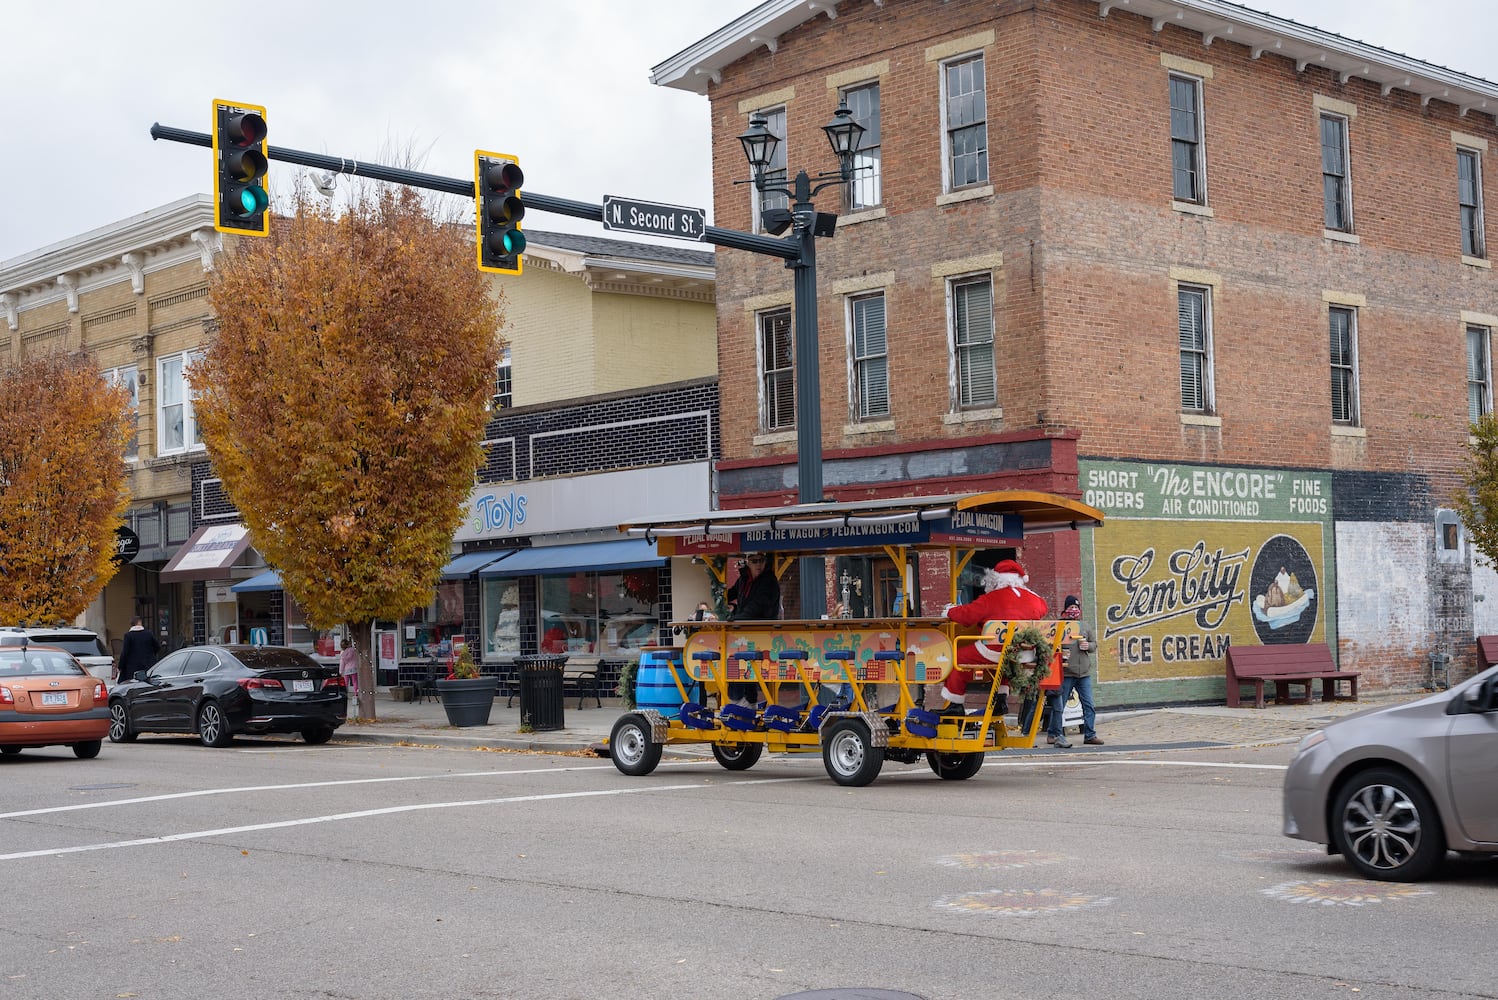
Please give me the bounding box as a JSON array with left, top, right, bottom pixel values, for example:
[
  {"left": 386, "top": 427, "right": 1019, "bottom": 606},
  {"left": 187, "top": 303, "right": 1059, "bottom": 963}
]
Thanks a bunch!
[{"left": 0, "top": 352, "right": 135, "bottom": 623}]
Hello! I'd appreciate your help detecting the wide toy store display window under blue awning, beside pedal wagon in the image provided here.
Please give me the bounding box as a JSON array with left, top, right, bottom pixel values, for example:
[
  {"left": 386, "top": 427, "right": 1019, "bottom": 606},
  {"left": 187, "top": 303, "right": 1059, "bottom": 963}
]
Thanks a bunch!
[{"left": 541, "top": 569, "right": 658, "bottom": 656}]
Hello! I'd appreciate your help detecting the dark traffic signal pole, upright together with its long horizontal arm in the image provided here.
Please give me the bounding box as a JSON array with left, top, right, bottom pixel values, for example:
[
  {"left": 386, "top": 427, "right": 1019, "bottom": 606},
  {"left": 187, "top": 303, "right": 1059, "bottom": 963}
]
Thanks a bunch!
[{"left": 151, "top": 123, "right": 827, "bottom": 618}]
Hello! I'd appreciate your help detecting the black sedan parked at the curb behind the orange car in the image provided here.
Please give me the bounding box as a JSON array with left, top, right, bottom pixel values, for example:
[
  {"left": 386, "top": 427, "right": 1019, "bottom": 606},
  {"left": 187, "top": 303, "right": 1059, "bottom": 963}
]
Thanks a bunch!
[{"left": 109, "top": 645, "right": 349, "bottom": 747}]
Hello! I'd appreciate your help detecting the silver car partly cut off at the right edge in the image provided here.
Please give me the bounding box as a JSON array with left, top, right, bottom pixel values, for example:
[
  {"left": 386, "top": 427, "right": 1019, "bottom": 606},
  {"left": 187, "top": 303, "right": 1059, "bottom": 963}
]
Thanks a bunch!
[{"left": 1284, "top": 666, "right": 1498, "bottom": 882}]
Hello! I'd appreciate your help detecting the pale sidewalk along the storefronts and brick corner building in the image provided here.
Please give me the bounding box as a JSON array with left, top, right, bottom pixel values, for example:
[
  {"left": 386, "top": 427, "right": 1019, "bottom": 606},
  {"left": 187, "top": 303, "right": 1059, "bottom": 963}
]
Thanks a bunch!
[{"left": 334, "top": 690, "right": 1428, "bottom": 753}]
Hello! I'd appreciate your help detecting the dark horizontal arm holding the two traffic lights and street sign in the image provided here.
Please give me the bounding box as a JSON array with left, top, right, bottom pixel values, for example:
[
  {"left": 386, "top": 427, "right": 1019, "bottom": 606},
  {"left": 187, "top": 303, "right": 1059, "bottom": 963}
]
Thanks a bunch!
[{"left": 151, "top": 123, "right": 801, "bottom": 260}]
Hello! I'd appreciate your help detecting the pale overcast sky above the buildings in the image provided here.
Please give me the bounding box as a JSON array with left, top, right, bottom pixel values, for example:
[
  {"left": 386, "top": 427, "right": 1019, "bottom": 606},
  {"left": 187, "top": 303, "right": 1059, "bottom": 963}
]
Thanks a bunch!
[{"left": 0, "top": 0, "right": 1498, "bottom": 260}]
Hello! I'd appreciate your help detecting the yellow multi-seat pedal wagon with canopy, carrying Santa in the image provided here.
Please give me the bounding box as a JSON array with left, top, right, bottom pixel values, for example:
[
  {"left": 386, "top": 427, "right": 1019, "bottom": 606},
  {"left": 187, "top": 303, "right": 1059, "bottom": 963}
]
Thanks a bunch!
[{"left": 610, "top": 490, "right": 1103, "bottom": 786}]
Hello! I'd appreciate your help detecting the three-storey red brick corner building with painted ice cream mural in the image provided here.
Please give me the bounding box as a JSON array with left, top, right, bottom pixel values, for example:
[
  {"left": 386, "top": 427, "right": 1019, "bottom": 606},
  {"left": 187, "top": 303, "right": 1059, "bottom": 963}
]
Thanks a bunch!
[{"left": 653, "top": 0, "right": 1498, "bottom": 704}]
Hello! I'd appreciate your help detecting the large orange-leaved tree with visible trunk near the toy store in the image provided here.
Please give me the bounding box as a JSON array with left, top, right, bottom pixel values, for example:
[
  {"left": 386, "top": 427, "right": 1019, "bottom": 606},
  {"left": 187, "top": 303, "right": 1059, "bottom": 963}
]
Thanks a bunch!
[{"left": 189, "top": 187, "right": 503, "bottom": 717}]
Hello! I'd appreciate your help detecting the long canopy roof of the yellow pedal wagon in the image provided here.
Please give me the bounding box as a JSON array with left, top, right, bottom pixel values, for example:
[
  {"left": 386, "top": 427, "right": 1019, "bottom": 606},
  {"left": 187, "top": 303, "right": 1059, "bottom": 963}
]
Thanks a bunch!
[{"left": 619, "top": 490, "right": 1103, "bottom": 555}]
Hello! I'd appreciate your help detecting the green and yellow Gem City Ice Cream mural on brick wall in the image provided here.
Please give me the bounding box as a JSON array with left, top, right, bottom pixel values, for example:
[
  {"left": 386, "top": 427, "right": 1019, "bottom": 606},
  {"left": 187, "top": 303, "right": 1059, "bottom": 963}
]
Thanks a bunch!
[{"left": 1080, "top": 461, "right": 1336, "bottom": 681}]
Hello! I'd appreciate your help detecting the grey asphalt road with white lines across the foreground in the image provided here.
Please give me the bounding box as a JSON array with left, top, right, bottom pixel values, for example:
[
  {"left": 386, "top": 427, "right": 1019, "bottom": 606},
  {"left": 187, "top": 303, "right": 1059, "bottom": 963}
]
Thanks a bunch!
[{"left": 0, "top": 740, "right": 1498, "bottom": 1000}]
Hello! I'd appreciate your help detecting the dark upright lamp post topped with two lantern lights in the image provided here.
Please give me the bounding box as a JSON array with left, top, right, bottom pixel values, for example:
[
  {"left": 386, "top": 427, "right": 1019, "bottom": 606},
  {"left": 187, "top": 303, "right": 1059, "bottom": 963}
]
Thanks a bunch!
[{"left": 739, "top": 103, "right": 864, "bottom": 618}]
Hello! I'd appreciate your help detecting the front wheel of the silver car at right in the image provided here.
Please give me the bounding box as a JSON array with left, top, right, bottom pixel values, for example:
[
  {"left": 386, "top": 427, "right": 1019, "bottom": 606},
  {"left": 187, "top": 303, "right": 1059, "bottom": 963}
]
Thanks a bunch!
[{"left": 1332, "top": 768, "right": 1446, "bottom": 882}]
